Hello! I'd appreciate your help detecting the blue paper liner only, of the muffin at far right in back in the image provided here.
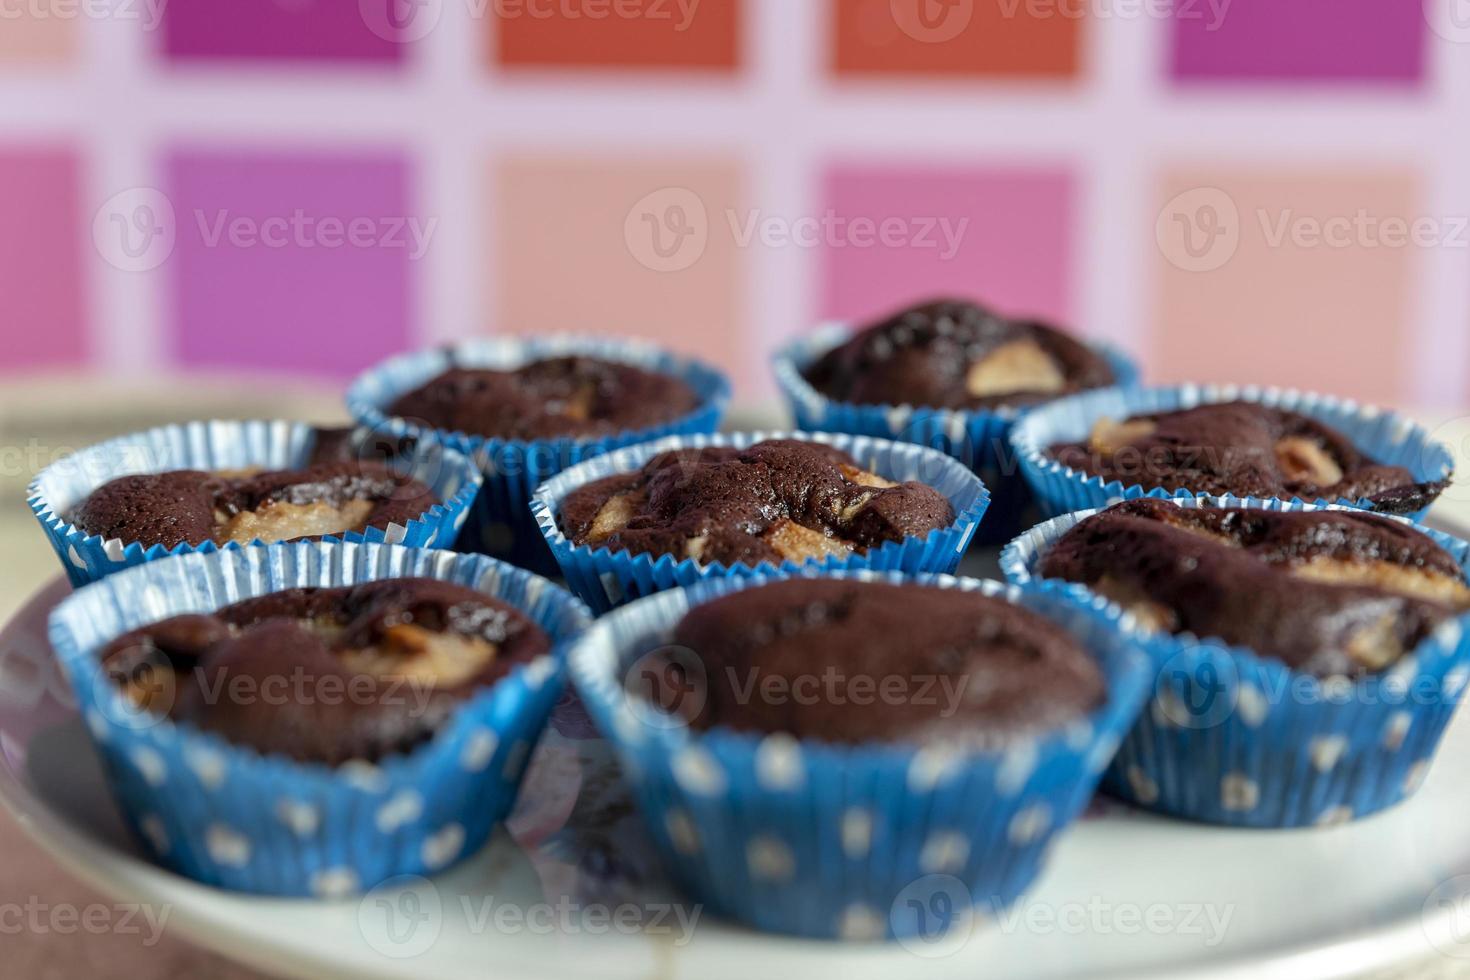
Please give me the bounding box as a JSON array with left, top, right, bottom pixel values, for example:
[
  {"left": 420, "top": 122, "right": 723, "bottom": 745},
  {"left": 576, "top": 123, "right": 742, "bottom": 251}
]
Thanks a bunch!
[{"left": 1011, "top": 385, "right": 1454, "bottom": 520}]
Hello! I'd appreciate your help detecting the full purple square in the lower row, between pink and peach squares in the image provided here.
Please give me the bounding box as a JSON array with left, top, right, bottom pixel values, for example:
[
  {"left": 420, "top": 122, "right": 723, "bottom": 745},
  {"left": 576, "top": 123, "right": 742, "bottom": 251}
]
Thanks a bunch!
[{"left": 166, "top": 151, "right": 417, "bottom": 378}]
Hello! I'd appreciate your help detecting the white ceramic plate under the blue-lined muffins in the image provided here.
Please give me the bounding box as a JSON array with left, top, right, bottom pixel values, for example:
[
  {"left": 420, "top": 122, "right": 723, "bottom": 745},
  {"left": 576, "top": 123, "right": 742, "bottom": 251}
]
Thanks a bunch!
[{"left": 0, "top": 528, "right": 1470, "bottom": 980}]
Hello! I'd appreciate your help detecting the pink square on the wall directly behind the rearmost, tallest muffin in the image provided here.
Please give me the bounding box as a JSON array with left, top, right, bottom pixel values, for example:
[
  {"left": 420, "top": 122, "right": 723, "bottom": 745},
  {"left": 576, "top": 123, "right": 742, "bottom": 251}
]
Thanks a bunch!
[{"left": 820, "top": 166, "right": 1076, "bottom": 333}]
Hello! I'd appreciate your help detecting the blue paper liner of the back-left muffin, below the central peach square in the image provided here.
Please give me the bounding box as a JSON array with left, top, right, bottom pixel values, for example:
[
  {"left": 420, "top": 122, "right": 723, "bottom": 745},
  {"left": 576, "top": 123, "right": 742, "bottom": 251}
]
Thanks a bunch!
[{"left": 347, "top": 336, "right": 731, "bottom": 573}]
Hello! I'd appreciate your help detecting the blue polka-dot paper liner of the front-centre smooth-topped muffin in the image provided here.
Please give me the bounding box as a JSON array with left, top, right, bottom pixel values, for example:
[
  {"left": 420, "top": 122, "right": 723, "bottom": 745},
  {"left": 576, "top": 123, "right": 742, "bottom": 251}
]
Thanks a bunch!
[{"left": 569, "top": 570, "right": 1150, "bottom": 942}]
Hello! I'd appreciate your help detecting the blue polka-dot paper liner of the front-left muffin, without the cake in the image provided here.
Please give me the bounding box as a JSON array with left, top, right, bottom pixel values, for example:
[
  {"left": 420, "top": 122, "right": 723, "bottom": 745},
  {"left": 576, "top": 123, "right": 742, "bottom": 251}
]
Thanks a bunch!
[{"left": 50, "top": 542, "right": 591, "bottom": 898}]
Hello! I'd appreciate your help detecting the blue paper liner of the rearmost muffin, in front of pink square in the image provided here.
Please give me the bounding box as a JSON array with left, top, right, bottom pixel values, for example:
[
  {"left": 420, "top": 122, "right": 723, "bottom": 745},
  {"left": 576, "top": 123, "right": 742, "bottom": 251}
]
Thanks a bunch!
[{"left": 775, "top": 323, "right": 1138, "bottom": 544}]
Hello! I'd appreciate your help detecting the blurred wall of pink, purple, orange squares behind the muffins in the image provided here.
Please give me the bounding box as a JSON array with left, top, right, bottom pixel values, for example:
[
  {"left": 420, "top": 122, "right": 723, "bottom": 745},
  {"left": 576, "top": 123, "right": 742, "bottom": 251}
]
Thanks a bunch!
[{"left": 0, "top": 0, "right": 1470, "bottom": 976}]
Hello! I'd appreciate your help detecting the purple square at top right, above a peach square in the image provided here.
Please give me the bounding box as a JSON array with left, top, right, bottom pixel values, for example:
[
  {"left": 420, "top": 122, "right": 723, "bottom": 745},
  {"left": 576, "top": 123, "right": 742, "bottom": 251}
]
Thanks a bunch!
[{"left": 1172, "top": 0, "right": 1429, "bottom": 82}]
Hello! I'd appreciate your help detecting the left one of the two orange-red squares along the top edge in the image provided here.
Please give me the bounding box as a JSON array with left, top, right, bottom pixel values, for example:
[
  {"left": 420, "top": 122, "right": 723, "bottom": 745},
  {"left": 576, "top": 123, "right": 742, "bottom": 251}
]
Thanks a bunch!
[{"left": 488, "top": 0, "right": 741, "bottom": 71}]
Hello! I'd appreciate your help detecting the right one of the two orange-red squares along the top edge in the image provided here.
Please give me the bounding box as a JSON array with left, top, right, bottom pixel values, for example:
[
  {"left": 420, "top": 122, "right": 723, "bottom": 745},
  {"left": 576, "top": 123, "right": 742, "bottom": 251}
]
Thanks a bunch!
[{"left": 828, "top": 0, "right": 1086, "bottom": 78}]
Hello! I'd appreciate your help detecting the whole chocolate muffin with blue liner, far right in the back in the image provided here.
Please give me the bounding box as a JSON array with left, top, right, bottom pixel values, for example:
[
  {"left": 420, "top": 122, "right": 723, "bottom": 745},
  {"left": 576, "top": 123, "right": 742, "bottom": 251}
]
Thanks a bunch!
[{"left": 1010, "top": 385, "right": 1454, "bottom": 520}]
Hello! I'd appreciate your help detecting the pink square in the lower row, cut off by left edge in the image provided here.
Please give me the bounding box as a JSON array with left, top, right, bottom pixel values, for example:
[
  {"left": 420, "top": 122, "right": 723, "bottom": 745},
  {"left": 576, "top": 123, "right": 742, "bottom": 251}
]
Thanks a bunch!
[{"left": 0, "top": 147, "right": 91, "bottom": 370}]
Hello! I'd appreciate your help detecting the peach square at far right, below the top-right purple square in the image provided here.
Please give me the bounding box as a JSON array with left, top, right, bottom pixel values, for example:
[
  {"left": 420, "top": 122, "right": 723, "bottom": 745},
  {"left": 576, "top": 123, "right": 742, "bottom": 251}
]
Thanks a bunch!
[{"left": 1147, "top": 169, "right": 1417, "bottom": 404}]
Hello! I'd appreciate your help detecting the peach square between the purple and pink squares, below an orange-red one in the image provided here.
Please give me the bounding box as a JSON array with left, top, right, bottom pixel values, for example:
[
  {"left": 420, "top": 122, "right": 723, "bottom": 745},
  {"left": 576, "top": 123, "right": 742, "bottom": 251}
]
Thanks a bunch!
[{"left": 485, "top": 156, "right": 763, "bottom": 385}]
